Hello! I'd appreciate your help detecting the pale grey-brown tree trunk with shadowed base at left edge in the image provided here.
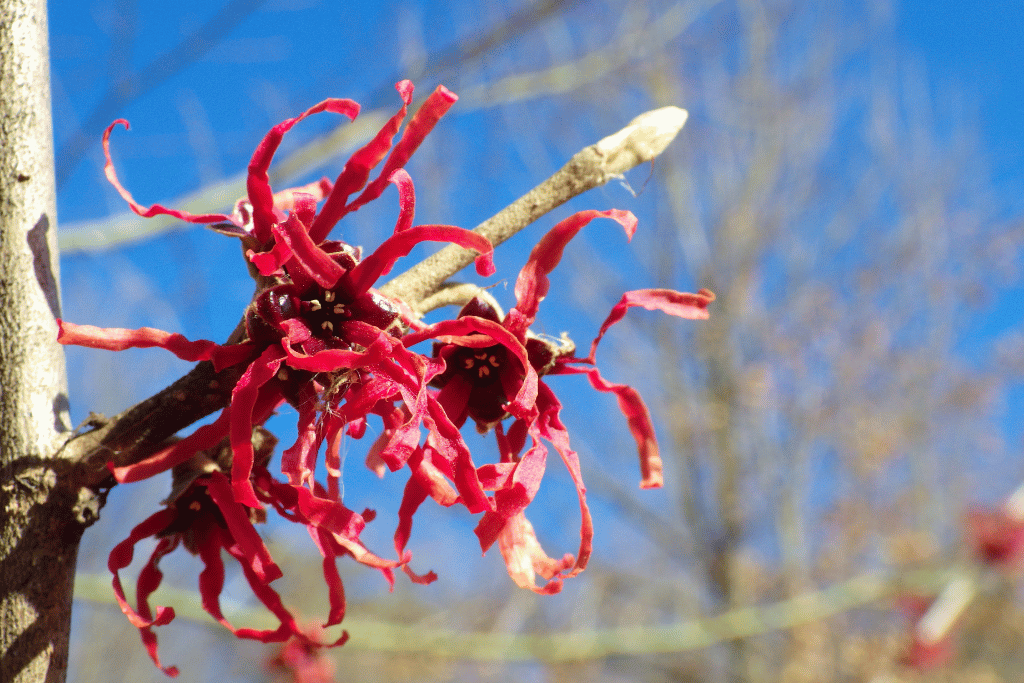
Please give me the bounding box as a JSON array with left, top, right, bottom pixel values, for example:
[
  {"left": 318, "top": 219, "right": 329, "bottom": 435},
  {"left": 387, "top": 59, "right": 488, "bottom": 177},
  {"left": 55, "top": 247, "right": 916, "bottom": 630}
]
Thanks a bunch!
[{"left": 0, "top": 0, "right": 84, "bottom": 683}]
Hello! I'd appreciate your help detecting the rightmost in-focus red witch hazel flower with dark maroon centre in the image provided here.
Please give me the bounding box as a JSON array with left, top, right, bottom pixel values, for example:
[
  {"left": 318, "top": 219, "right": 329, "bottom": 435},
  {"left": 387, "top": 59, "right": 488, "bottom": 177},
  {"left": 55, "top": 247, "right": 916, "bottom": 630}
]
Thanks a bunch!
[{"left": 395, "top": 210, "right": 715, "bottom": 593}]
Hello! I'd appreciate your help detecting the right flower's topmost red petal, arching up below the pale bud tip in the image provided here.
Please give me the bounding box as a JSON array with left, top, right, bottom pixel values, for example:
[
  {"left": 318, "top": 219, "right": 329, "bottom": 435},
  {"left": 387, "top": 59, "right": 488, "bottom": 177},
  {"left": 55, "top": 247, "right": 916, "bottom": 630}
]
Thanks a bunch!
[{"left": 505, "top": 209, "right": 637, "bottom": 338}]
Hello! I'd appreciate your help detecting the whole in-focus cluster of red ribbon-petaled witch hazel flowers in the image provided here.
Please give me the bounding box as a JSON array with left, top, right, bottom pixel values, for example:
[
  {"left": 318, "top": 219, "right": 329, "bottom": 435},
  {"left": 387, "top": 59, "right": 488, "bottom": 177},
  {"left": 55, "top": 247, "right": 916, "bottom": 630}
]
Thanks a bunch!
[{"left": 59, "top": 81, "right": 714, "bottom": 675}]
